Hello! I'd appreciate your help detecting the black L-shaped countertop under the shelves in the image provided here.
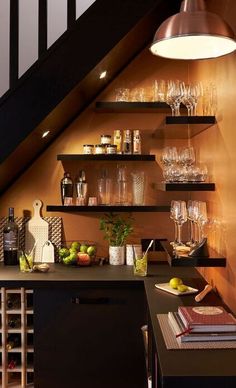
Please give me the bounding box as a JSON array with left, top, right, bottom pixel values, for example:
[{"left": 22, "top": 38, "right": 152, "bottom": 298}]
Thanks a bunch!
[{"left": 0, "top": 263, "right": 236, "bottom": 388}]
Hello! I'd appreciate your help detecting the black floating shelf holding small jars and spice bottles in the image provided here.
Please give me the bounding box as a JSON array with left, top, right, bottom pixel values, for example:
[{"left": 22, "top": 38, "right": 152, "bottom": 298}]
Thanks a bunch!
[{"left": 57, "top": 154, "right": 155, "bottom": 162}]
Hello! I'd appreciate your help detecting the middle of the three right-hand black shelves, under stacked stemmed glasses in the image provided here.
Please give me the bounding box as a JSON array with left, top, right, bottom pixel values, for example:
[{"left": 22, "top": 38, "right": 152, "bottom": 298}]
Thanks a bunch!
[{"left": 154, "top": 182, "right": 215, "bottom": 191}]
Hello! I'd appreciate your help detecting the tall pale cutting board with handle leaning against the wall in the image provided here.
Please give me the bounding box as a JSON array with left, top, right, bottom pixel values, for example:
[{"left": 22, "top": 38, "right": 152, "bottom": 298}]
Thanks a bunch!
[{"left": 25, "top": 199, "right": 48, "bottom": 262}]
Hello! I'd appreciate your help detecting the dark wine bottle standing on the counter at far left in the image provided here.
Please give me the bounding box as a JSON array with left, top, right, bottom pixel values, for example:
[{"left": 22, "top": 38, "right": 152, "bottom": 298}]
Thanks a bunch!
[{"left": 3, "top": 207, "right": 19, "bottom": 265}]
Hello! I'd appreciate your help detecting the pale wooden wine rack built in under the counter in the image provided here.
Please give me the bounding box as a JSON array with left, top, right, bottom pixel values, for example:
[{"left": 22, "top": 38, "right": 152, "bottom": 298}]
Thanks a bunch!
[{"left": 0, "top": 287, "right": 34, "bottom": 388}]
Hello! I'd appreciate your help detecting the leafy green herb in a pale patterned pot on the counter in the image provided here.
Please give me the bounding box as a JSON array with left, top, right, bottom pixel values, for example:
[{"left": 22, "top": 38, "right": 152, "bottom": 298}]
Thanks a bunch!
[{"left": 100, "top": 213, "right": 133, "bottom": 265}]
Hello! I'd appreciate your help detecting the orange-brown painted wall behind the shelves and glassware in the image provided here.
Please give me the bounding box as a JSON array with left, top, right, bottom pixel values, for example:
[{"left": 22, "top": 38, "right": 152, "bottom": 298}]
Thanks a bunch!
[{"left": 0, "top": 0, "right": 236, "bottom": 312}]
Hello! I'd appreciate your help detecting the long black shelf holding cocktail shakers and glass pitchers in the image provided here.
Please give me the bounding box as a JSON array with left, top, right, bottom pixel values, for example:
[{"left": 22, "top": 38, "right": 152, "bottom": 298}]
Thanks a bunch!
[{"left": 47, "top": 205, "right": 170, "bottom": 213}]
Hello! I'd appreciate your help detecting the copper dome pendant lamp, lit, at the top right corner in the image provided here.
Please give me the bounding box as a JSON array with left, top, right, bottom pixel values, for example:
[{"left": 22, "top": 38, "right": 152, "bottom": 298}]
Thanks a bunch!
[{"left": 150, "top": 0, "right": 236, "bottom": 60}]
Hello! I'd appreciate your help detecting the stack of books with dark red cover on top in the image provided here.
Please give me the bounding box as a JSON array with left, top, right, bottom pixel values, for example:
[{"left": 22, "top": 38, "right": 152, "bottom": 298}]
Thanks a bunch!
[{"left": 168, "top": 306, "right": 236, "bottom": 342}]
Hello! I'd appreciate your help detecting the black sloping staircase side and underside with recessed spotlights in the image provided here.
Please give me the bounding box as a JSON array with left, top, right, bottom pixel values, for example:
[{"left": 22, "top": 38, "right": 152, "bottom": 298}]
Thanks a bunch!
[{"left": 0, "top": 0, "right": 180, "bottom": 194}]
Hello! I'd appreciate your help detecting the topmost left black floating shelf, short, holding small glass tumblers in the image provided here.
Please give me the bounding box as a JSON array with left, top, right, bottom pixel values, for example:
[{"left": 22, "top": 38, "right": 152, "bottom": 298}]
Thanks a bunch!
[{"left": 96, "top": 101, "right": 170, "bottom": 113}]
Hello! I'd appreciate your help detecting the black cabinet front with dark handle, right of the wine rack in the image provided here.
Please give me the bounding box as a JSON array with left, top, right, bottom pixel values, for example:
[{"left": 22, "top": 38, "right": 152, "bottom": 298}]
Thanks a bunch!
[{"left": 34, "top": 284, "right": 146, "bottom": 388}]
